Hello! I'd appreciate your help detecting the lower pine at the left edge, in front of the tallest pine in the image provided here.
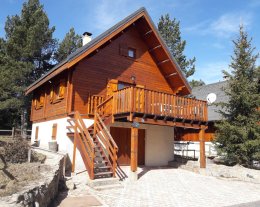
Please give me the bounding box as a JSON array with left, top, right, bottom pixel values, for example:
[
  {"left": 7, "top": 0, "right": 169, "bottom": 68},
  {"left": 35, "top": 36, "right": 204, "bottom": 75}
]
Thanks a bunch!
[{"left": 0, "top": 39, "right": 32, "bottom": 128}]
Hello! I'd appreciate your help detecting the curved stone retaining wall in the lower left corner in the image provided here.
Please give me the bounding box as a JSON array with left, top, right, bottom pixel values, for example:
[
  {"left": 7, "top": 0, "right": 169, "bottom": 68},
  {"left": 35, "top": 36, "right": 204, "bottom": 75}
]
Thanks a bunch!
[{"left": 0, "top": 149, "right": 65, "bottom": 207}]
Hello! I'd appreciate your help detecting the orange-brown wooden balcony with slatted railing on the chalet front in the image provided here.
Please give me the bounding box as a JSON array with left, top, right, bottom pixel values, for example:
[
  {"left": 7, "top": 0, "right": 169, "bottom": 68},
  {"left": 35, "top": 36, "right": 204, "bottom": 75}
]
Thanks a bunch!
[{"left": 89, "top": 87, "right": 208, "bottom": 129}]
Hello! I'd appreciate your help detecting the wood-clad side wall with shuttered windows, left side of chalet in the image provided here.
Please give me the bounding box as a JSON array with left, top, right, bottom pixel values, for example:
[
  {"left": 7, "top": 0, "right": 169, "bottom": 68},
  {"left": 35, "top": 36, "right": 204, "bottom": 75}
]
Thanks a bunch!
[{"left": 31, "top": 71, "right": 68, "bottom": 122}]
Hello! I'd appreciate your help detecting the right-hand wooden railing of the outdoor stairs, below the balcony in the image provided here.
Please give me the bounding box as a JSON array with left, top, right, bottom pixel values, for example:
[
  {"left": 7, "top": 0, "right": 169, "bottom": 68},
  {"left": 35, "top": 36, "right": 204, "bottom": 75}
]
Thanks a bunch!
[{"left": 94, "top": 96, "right": 118, "bottom": 177}]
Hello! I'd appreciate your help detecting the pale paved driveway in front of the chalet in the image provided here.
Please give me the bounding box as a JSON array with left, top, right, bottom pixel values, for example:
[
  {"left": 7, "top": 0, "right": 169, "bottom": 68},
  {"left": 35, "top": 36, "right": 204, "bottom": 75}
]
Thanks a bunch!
[{"left": 91, "top": 168, "right": 260, "bottom": 207}]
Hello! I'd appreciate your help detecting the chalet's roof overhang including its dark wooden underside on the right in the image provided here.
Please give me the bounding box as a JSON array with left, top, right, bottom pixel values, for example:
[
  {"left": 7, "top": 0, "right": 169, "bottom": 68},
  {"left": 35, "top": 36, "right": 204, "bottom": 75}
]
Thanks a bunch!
[{"left": 25, "top": 8, "right": 191, "bottom": 95}]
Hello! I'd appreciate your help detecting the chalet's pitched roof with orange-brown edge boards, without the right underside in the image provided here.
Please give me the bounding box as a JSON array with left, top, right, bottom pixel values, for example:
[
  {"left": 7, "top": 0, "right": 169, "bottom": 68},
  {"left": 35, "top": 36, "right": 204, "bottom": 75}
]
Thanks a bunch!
[{"left": 25, "top": 7, "right": 191, "bottom": 95}]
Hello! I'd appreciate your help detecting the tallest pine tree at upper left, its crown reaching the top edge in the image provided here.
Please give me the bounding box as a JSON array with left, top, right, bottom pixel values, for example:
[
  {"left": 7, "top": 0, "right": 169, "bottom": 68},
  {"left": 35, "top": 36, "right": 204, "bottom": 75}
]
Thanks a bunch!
[{"left": 5, "top": 0, "right": 57, "bottom": 85}]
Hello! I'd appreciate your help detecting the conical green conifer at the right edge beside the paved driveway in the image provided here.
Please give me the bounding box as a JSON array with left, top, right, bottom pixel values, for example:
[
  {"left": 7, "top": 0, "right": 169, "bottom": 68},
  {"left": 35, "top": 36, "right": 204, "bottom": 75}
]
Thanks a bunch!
[{"left": 215, "top": 26, "right": 260, "bottom": 166}]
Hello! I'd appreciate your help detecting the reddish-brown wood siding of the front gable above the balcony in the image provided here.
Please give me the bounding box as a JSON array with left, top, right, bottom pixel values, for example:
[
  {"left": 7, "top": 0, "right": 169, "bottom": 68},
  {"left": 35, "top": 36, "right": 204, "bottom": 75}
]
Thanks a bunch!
[{"left": 72, "top": 27, "right": 173, "bottom": 113}]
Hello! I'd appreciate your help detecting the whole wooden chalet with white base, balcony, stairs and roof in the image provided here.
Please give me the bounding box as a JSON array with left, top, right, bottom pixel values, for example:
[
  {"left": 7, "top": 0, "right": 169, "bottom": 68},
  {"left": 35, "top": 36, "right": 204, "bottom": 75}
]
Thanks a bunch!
[{"left": 26, "top": 8, "right": 207, "bottom": 179}]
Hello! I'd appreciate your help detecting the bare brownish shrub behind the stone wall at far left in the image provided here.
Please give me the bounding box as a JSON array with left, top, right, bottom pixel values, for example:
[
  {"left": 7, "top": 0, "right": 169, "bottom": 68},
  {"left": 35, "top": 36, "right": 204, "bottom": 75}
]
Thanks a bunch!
[{"left": 4, "top": 138, "right": 30, "bottom": 163}]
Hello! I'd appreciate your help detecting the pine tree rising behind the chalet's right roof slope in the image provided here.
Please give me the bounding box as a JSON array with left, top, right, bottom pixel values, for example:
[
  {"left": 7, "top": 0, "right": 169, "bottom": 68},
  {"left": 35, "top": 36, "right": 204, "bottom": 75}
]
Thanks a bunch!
[{"left": 158, "top": 14, "right": 196, "bottom": 78}]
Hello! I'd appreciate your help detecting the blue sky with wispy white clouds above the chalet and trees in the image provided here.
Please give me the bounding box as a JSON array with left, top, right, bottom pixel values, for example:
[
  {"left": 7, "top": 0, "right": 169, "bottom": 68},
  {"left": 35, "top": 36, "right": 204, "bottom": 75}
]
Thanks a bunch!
[{"left": 0, "top": 0, "right": 260, "bottom": 83}]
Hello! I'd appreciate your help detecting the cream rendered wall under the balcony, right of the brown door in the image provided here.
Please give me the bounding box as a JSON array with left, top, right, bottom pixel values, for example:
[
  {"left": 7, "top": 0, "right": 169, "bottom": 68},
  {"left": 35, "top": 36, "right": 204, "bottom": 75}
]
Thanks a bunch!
[{"left": 108, "top": 122, "right": 174, "bottom": 166}]
